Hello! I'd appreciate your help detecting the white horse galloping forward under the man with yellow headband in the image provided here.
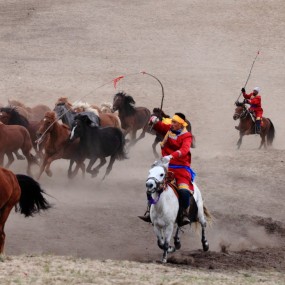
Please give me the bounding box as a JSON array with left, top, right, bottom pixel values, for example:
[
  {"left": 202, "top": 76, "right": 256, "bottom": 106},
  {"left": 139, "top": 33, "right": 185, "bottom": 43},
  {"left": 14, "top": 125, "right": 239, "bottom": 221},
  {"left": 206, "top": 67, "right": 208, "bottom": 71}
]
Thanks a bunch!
[{"left": 146, "top": 160, "right": 211, "bottom": 263}]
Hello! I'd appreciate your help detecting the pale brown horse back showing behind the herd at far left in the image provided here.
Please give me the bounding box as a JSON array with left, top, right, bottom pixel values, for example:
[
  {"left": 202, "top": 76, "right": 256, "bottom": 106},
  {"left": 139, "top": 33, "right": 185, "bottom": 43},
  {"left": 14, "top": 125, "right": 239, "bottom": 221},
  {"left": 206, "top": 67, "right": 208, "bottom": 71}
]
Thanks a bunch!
[{"left": 8, "top": 100, "right": 50, "bottom": 121}]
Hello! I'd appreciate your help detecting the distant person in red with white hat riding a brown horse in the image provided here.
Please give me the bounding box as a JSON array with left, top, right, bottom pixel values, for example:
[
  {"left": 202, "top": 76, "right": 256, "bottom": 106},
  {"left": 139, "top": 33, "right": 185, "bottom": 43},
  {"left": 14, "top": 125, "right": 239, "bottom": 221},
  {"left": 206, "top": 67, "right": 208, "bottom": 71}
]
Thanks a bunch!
[{"left": 241, "top": 87, "right": 263, "bottom": 134}]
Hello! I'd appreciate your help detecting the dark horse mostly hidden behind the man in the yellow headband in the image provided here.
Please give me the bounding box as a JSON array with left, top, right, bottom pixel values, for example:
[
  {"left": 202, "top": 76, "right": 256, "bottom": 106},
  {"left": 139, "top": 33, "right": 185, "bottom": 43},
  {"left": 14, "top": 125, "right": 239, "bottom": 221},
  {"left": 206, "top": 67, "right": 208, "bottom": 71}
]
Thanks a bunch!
[{"left": 151, "top": 108, "right": 196, "bottom": 158}]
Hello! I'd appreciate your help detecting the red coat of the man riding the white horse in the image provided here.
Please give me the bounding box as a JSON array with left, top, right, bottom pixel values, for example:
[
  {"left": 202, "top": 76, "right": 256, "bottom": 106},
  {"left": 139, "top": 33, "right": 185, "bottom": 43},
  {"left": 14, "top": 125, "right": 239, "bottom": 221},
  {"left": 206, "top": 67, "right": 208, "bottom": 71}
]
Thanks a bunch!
[{"left": 153, "top": 122, "right": 194, "bottom": 191}]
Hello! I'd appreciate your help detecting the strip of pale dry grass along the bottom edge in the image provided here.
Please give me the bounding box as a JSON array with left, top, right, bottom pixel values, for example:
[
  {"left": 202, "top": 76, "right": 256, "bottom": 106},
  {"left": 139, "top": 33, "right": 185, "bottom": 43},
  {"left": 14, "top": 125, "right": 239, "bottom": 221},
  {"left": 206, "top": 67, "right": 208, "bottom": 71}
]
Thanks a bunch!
[{"left": 0, "top": 255, "right": 284, "bottom": 285}]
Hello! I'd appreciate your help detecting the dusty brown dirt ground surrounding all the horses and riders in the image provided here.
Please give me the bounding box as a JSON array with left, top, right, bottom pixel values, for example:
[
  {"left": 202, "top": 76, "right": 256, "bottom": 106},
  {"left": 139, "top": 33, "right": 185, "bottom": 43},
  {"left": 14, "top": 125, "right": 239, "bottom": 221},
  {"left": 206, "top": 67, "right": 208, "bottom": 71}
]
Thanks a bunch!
[{"left": 0, "top": 0, "right": 285, "bottom": 284}]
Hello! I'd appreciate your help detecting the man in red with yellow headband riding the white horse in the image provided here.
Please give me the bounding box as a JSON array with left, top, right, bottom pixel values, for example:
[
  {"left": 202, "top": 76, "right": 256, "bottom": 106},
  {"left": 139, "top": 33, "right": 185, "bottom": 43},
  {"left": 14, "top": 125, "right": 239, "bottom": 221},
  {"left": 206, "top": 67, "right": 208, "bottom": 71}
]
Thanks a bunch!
[{"left": 139, "top": 113, "right": 195, "bottom": 226}]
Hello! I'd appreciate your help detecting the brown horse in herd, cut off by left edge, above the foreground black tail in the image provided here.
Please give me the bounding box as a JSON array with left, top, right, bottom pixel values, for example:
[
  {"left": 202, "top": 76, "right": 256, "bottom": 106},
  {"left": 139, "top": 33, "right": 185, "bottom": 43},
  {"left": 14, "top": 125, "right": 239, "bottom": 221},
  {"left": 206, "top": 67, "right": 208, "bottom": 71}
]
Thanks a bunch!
[{"left": 0, "top": 122, "right": 38, "bottom": 175}]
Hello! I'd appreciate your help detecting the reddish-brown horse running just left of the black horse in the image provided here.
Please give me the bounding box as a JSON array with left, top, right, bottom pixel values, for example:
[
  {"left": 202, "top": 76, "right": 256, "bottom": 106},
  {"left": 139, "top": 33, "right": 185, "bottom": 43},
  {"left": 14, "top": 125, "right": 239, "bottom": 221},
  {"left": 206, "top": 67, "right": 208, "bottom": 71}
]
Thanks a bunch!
[{"left": 37, "top": 111, "right": 85, "bottom": 179}]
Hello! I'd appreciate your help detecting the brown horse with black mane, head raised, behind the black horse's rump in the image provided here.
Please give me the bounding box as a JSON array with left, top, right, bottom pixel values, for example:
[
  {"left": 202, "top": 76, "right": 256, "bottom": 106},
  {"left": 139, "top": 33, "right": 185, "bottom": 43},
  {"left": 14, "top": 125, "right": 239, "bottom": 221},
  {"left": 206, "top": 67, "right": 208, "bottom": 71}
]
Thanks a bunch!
[{"left": 112, "top": 92, "right": 150, "bottom": 145}]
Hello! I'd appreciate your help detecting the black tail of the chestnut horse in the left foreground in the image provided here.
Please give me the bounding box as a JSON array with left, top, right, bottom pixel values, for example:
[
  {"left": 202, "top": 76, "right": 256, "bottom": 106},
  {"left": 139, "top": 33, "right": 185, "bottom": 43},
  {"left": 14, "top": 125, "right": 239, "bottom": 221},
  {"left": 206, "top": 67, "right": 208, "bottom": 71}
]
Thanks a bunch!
[{"left": 16, "top": 174, "right": 51, "bottom": 217}]
